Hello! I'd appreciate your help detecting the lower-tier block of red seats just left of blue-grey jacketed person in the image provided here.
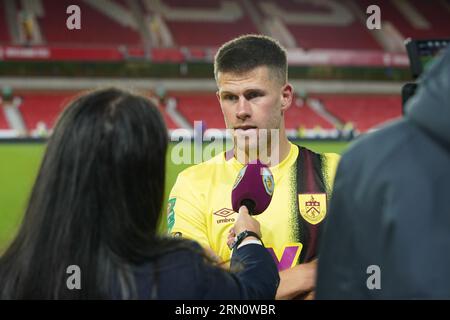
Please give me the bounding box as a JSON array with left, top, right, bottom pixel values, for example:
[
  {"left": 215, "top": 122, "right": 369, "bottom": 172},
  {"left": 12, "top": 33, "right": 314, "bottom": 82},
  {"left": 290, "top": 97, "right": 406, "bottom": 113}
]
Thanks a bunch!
[{"left": 320, "top": 95, "right": 401, "bottom": 132}]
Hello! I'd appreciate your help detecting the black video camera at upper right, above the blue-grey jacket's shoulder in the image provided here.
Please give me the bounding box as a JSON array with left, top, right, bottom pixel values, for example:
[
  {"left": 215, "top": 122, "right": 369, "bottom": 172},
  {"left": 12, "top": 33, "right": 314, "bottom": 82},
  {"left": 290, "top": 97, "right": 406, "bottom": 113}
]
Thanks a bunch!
[{"left": 402, "top": 38, "right": 450, "bottom": 114}]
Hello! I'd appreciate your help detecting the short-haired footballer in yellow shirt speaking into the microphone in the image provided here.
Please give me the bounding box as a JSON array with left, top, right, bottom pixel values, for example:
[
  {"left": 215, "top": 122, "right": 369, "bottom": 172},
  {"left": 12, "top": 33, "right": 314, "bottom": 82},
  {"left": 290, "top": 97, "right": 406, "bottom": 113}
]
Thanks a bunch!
[{"left": 168, "top": 35, "right": 339, "bottom": 299}]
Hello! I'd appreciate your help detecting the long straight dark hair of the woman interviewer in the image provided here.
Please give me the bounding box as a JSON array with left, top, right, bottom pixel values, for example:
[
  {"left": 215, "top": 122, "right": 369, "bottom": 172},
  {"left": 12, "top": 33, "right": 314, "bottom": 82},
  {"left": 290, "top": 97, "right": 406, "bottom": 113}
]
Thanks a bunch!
[{"left": 0, "top": 88, "right": 185, "bottom": 299}]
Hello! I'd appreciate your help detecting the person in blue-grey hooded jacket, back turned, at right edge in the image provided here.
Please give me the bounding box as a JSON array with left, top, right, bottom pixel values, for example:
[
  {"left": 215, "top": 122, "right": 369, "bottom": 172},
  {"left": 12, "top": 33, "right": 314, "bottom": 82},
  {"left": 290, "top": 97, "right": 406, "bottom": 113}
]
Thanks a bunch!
[{"left": 317, "top": 50, "right": 450, "bottom": 299}]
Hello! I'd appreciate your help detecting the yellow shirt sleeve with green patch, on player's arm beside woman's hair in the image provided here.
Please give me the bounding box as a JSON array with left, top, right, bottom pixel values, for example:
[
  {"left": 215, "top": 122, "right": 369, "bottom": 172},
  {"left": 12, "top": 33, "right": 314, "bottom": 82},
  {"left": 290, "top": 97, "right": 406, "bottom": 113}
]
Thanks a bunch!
[{"left": 167, "top": 171, "right": 211, "bottom": 247}]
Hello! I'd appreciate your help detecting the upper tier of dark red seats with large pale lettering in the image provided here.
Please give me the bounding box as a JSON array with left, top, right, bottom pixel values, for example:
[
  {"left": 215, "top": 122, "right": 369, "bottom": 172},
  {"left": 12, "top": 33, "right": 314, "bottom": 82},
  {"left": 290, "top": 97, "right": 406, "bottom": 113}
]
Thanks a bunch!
[{"left": 0, "top": 0, "right": 450, "bottom": 55}]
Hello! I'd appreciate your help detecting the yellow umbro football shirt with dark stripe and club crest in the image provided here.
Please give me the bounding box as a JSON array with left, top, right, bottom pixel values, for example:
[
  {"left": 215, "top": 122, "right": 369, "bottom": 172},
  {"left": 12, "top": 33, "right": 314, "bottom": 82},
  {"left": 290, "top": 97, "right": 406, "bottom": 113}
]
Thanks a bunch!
[{"left": 167, "top": 144, "right": 339, "bottom": 270}]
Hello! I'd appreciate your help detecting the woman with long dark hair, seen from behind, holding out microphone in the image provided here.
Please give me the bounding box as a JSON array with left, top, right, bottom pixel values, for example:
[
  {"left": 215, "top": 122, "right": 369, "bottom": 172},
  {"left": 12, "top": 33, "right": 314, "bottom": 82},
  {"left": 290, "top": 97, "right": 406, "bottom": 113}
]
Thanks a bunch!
[{"left": 0, "top": 89, "right": 279, "bottom": 299}]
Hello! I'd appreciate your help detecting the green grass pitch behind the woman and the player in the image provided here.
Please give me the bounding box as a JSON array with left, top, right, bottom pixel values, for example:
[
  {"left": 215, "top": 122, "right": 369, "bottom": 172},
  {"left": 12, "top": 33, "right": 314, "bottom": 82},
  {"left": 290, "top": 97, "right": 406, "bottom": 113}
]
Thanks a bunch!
[{"left": 0, "top": 142, "right": 348, "bottom": 253}]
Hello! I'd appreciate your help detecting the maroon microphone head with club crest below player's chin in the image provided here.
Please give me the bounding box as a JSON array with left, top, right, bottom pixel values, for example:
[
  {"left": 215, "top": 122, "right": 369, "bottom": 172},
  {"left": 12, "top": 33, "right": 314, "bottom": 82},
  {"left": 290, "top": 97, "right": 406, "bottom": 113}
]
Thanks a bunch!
[{"left": 231, "top": 159, "right": 275, "bottom": 215}]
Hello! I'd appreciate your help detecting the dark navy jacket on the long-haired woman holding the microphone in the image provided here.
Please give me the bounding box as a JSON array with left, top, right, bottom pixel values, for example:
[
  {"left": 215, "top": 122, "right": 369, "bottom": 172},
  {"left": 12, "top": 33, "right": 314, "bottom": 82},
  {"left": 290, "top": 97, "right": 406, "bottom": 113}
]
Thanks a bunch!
[{"left": 121, "top": 240, "right": 280, "bottom": 300}]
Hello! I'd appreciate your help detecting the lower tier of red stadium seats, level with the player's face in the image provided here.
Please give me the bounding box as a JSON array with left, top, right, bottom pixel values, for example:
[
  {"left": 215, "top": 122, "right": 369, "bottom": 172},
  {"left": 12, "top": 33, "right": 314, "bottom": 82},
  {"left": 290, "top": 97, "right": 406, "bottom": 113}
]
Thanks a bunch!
[{"left": 11, "top": 92, "right": 401, "bottom": 132}]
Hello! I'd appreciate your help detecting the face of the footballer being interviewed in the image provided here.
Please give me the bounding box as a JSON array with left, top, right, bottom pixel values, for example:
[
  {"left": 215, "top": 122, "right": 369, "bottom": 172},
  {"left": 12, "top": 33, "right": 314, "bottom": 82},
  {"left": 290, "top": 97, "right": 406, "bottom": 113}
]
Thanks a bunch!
[{"left": 217, "top": 66, "right": 292, "bottom": 159}]
